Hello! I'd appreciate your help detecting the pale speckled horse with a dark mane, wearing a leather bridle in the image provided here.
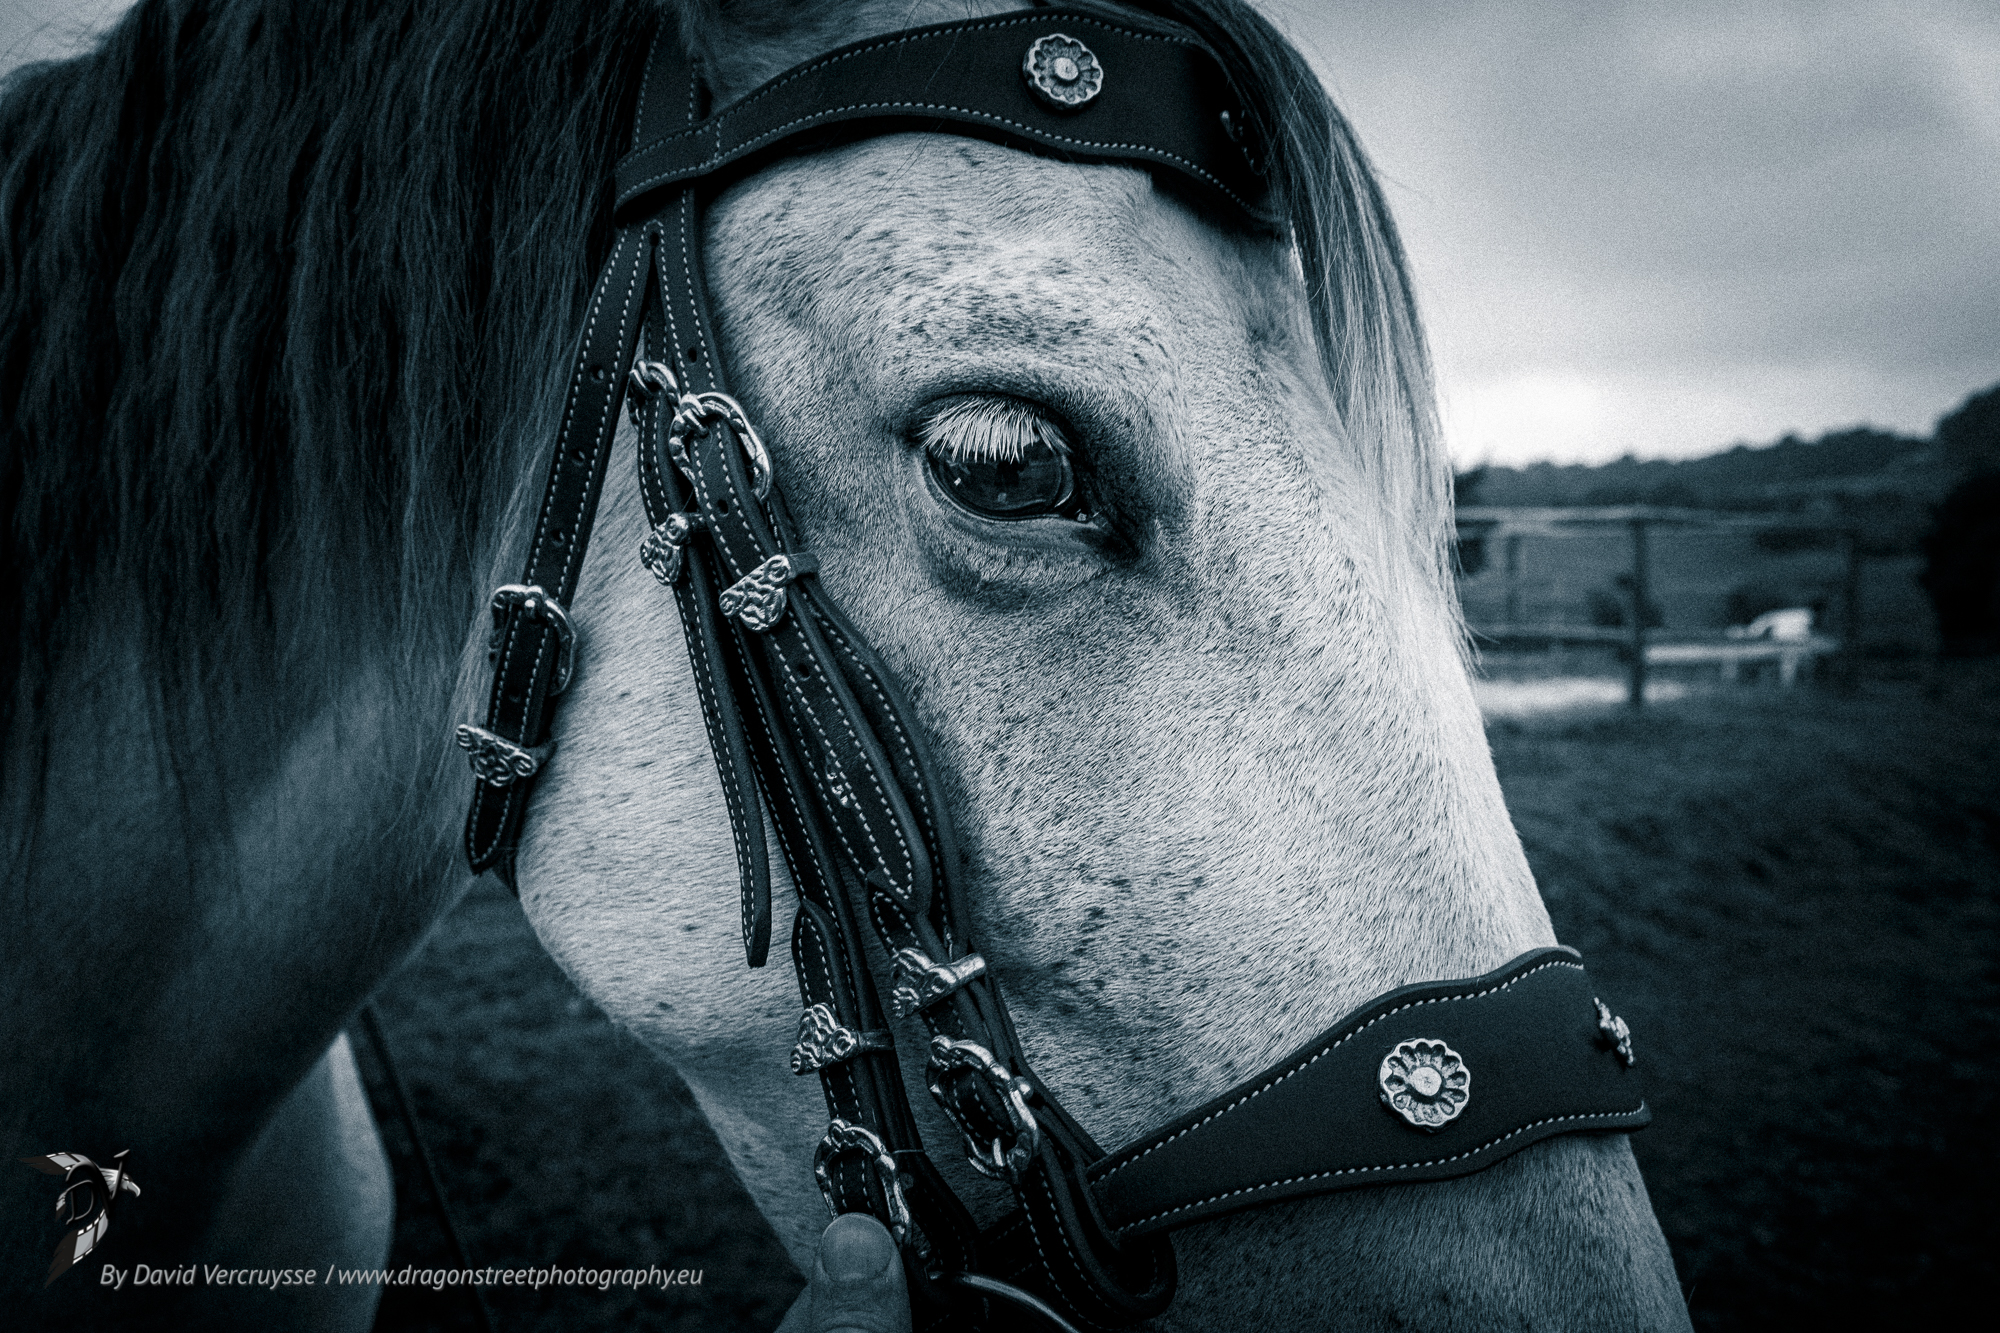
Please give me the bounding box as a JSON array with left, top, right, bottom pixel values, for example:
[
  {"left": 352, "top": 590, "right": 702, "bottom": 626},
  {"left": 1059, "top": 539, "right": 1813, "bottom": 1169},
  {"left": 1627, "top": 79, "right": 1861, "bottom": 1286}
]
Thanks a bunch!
[{"left": 0, "top": 0, "right": 1688, "bottom": 1329}]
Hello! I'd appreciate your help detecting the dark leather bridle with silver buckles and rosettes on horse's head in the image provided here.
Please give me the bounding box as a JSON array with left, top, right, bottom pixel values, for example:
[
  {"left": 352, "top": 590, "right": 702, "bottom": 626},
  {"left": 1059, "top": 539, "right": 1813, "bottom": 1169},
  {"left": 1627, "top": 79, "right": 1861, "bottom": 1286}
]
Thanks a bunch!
[{"left": 458, "top": 10, "right": 1650, "bottom": 1333}]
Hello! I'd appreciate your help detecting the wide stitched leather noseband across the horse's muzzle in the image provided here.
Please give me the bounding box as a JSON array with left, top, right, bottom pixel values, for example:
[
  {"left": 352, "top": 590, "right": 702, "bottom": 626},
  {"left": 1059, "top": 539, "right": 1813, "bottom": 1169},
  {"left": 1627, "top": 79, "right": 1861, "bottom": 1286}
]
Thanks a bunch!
[{"left": 1090, "top": 949, "right": 1652, "bottom": 1235}]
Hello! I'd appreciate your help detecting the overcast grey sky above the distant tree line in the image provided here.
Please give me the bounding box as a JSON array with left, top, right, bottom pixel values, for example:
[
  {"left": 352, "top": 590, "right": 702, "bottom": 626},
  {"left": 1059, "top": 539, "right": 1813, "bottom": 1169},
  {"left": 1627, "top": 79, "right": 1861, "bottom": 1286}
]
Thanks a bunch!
[{"left": 11, "top": 0, "right": 2000, "bottom": 466}]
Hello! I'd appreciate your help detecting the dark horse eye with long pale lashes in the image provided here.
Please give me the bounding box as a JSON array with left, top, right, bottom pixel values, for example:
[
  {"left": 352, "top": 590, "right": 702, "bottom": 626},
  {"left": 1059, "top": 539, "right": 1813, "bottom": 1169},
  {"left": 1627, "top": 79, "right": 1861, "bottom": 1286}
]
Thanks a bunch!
[{"left": 916, "top": 398, "right": 1084, "bottom": 518}]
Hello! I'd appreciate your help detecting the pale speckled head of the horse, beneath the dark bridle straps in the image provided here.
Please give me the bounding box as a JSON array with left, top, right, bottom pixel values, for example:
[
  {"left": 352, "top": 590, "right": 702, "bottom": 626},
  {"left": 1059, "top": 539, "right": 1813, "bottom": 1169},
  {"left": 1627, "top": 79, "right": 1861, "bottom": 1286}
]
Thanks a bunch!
[{"left": 518, "top": 4, "right": 1684, "bottom": 1327}]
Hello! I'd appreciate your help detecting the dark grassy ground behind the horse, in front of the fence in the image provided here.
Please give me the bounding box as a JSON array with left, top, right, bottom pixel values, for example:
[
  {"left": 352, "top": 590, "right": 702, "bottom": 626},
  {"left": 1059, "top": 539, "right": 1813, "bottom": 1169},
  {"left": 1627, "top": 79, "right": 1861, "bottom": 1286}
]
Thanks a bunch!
[{"left": 364, "top": 669, "right": 2000, "bottom": 1333}]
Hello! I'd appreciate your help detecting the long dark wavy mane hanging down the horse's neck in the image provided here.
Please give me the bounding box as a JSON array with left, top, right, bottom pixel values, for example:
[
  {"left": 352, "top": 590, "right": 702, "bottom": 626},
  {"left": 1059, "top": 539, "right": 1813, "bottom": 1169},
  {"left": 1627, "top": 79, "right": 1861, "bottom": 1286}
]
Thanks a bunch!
[{"left": 0, "top": 0, "right": 660, "bottom": 808}]
